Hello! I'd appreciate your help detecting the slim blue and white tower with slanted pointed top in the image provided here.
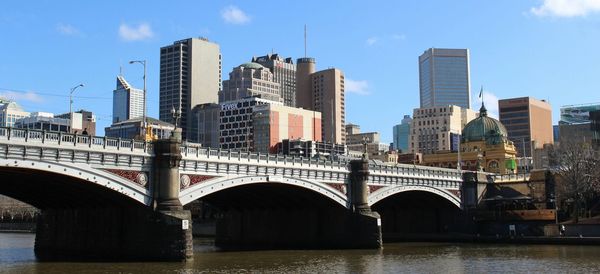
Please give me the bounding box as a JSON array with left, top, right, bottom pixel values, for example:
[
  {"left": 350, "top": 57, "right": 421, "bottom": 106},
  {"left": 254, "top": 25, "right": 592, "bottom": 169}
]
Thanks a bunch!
[{"left": 113, "top": 75, "right": 144, "bottom": 123}]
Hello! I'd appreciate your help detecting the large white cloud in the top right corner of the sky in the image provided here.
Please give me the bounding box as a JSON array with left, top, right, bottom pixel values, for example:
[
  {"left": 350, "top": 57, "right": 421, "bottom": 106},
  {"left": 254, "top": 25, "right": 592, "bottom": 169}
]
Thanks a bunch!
[{"left": 530, "top": 0, "right": 600, "bottom": 17}]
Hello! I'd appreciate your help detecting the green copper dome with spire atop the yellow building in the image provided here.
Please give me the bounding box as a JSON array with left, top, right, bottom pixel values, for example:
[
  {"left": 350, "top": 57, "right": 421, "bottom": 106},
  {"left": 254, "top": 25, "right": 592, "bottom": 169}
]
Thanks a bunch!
[{"left": 462, "top": 104, "right": 508, "bottom": 144}]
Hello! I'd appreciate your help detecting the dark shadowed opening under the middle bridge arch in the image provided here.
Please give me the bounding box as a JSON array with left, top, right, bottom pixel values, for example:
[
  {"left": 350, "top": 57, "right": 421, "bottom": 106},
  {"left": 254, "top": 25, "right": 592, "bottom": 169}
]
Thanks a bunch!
[{"left": 202, "top": 183, "right": 347, "bottom": 249}]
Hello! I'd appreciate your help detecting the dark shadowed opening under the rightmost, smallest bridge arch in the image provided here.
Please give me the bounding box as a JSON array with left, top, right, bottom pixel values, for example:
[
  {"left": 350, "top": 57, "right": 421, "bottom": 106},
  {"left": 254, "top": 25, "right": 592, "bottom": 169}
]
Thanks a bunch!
[{"left": 372, "top": 191, "right": 466, "bottom": 241}]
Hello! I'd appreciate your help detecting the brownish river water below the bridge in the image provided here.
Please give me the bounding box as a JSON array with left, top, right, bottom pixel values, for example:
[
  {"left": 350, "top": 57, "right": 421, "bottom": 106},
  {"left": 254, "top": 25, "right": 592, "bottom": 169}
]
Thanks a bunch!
[{"left": 0, "top": 233, "right": 600, "bottom": 273}]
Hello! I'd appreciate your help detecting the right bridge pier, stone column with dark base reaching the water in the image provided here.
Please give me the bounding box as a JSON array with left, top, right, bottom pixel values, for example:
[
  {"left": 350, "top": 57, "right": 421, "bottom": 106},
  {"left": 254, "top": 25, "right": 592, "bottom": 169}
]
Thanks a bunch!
[{"left": 347, "top": 158, "right": 382, "bottom": 248}]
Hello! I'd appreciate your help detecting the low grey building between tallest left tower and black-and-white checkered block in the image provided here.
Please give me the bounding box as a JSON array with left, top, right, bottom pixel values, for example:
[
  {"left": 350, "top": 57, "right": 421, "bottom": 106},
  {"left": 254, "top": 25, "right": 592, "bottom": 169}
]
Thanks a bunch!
[{"left": 188, "top": 103, "right": 221, "bottom": 148}]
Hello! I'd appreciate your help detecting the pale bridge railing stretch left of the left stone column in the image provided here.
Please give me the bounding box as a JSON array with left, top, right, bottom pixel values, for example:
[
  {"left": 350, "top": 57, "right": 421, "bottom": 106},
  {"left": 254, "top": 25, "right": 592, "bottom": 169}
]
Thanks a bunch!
[{"left": 0, "top": 127, "right": 152, "bottom": 152}]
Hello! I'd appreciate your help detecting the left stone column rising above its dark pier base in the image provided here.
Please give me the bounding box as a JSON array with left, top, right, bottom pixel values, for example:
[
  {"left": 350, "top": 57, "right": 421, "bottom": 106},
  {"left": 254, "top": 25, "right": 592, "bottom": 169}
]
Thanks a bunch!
[{"left": 154, "top": 128, "right": 183, "bottom": 211}]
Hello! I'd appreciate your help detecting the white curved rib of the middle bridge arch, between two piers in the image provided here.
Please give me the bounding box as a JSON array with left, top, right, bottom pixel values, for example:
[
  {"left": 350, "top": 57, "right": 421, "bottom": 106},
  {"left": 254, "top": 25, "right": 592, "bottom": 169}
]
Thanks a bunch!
[{"left": 179, "top": 176, "right": 348, "bottom": 208}]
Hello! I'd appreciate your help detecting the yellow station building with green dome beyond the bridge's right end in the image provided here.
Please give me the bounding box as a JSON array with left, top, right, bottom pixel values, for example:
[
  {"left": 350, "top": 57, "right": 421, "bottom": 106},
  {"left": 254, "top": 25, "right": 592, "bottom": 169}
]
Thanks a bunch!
[{"left": 423, "top": 104, "right": 517, "bottom": 174}]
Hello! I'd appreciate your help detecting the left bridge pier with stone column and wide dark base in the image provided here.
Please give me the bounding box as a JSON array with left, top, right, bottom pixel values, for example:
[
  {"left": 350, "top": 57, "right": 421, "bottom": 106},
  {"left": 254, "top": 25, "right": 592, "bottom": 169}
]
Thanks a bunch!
[{"left": 35, "top": 129, "right": 193, "bottom": 261}]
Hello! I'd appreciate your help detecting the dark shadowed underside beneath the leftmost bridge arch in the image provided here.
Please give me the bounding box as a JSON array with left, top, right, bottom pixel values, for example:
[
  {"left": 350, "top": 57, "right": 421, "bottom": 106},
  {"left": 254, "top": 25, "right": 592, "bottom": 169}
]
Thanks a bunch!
[{"left": 0, "top": 167, "right": 141, "bottom": 209}]
